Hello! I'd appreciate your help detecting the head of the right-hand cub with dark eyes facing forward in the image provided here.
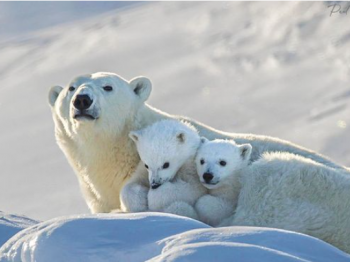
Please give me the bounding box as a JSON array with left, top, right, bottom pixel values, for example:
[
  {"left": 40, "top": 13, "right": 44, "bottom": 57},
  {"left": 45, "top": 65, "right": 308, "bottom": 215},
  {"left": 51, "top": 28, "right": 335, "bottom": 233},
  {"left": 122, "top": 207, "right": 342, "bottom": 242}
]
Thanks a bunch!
[{"left": 196, "top": 137, "right": 252, "bottom": 189}]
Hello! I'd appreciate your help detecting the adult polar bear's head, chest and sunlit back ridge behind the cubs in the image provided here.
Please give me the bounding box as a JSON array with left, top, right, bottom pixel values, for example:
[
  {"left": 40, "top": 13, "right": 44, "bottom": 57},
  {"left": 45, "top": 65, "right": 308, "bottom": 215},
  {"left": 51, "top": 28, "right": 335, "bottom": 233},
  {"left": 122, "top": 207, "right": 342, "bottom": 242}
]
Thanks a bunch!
[{"left": 49, "top": 73, "right": 344, "bottom": 213}]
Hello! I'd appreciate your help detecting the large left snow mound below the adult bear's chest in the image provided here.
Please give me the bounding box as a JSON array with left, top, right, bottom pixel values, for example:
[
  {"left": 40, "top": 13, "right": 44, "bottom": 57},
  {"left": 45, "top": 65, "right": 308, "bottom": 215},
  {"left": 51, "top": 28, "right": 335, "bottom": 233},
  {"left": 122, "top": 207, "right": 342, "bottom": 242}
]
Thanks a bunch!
[{"left": 0, "top": 213, "right": 208, "bottom": 262}]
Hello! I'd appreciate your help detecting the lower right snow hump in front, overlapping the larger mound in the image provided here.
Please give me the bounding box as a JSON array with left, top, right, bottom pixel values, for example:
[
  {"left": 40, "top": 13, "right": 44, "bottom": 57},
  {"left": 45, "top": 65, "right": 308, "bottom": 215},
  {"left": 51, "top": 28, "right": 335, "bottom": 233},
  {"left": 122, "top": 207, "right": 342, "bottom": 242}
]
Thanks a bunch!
[{"left": 151, "top": 227, "right": 350, "bottom": 262}]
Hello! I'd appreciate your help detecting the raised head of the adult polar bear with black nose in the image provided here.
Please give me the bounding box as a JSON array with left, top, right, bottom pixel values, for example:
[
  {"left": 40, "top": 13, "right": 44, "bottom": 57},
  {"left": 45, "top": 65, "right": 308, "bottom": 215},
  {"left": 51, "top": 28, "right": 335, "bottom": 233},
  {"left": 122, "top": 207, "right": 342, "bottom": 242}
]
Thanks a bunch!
[{"left": 49, "top": 73, "right": 152, "bottom": 140}]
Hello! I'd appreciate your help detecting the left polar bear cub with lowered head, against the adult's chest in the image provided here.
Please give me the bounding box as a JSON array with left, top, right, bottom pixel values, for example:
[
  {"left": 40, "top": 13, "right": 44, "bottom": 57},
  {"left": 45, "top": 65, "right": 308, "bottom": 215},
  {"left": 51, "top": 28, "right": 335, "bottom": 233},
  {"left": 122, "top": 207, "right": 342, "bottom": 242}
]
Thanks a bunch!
[{"left": 120, "top": 119, "right": 206, "bottom": 219}]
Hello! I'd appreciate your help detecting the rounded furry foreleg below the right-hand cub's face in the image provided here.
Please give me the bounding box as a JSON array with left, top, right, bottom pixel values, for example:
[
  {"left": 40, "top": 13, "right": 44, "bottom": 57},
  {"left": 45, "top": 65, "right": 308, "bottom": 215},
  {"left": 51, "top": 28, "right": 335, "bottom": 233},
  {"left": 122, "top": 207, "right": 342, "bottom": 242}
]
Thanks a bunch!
[{"left": 195, "top": 195, "right": 234, "bottom": 227}]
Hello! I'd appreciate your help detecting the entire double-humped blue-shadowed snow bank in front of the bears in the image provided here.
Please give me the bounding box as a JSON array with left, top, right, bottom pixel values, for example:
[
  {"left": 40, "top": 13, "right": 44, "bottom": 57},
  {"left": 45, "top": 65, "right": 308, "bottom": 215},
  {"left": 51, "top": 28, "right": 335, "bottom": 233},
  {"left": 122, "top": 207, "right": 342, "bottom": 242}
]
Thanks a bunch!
[{"left": 0, "top": 213, "right": 350, "bottom": 262}]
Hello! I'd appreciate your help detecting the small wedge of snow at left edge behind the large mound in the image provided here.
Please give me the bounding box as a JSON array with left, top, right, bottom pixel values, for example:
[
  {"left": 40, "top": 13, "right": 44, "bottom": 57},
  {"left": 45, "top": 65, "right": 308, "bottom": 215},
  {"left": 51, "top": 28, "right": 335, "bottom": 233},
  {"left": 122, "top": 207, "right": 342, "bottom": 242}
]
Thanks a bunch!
[{"left": 0, "top": 211, "right": 38, "bottom": 247}]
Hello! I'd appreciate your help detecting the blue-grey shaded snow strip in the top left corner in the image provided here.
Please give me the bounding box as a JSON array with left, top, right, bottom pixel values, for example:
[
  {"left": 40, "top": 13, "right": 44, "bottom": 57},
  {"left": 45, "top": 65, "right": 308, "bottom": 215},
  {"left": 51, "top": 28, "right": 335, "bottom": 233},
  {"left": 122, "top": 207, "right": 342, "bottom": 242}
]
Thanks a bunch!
[{"left": 0, "top": 1, "right": 139, "bottom": 39}]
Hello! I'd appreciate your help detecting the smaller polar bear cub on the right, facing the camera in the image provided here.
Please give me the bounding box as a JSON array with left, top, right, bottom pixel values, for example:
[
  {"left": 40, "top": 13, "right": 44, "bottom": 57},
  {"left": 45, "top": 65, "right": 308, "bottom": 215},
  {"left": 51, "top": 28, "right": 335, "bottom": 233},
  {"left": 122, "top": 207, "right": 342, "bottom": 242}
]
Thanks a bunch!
[{"left": 195, "top": 138, "right": 252, "bottom": 226}]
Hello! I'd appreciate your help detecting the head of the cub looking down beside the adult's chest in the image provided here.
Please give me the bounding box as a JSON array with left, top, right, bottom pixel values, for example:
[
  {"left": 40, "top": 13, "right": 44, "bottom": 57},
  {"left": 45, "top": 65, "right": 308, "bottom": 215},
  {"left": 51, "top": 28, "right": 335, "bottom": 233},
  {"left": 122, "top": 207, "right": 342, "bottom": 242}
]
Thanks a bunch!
[{"left": 130, "top": 120, "right": 200, "bottom": 189}]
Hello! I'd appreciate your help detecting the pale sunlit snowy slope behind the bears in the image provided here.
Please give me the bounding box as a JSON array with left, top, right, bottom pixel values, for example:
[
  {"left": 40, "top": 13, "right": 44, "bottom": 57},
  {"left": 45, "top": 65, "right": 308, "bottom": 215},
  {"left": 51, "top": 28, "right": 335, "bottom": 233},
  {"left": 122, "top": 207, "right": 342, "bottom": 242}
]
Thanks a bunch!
[{"left": 0, "top": 2, "right": 350, "bottom": 223}]
